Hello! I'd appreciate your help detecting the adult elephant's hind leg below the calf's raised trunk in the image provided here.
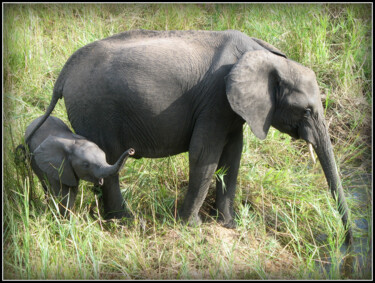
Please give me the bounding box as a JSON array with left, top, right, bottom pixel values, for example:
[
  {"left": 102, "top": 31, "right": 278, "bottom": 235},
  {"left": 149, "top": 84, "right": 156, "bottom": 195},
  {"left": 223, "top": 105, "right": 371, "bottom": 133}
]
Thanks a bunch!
[{"left": 102, "top": 174, "right": 131, "bottom": 222}]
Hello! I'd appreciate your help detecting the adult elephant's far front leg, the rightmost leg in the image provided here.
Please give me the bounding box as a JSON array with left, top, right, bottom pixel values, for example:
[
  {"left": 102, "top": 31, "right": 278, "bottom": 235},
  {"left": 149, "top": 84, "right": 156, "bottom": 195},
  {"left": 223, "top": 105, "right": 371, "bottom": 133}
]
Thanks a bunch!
[{"left": 215, "top": 129, "right": 243, "bottom": 228}]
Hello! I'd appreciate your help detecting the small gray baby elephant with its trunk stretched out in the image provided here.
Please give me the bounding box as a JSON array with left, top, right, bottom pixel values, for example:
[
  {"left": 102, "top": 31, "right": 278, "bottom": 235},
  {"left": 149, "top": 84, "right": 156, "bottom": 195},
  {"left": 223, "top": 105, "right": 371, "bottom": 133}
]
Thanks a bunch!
[{"left": 16, "top": 116, "right": 135, "bottom": 215}]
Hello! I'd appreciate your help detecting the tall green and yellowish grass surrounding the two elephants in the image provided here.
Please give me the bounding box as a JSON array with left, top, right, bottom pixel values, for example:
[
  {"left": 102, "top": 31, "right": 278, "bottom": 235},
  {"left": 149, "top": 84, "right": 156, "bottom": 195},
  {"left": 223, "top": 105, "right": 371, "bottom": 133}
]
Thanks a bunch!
[{"left": 3, "top": 4, "right": 372, "bottom": 279}]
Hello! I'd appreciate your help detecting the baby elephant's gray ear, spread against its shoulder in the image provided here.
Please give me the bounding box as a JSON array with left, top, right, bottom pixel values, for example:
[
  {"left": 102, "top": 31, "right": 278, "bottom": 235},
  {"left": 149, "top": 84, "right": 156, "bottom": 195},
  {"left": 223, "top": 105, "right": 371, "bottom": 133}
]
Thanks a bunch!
[{"left": 33, "top": 136, "right": 78, "bottom": 187}]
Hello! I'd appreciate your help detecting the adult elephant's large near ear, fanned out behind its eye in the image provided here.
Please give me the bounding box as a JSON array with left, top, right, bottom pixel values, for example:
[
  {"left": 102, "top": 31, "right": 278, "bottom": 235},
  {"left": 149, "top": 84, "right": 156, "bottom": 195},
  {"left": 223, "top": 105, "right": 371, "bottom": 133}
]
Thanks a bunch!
[{"left": 225, "top": 50, "right": 286, "bottom": 140}]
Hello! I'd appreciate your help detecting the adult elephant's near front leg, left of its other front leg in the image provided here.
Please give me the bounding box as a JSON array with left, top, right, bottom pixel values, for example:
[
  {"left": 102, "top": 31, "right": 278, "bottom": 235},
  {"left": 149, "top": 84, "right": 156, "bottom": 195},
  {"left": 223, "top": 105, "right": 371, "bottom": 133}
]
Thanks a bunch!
[{"left": 179, "top": 128, "right": 223, "bottom": 225}]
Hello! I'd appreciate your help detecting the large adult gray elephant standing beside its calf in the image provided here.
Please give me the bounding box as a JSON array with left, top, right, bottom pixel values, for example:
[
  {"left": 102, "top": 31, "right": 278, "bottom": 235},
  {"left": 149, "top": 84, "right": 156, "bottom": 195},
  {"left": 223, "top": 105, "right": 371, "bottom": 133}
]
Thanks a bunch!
[{"left": 27, "top": 30, "right": 352, "bottom": 242}]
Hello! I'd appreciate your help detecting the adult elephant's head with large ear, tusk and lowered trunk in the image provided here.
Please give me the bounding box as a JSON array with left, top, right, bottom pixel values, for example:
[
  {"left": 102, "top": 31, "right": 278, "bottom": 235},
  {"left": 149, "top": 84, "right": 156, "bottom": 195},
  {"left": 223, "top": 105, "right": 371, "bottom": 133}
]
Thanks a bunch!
[{"left": 226, "top": 50, "right": 352, "bottom": 243}]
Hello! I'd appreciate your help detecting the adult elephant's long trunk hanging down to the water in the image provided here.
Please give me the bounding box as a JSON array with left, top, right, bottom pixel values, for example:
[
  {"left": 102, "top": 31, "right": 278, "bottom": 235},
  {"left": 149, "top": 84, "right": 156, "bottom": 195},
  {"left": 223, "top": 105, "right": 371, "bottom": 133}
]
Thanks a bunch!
[{"left": 314, "top": 122, "right": 353, "bottom": 244}]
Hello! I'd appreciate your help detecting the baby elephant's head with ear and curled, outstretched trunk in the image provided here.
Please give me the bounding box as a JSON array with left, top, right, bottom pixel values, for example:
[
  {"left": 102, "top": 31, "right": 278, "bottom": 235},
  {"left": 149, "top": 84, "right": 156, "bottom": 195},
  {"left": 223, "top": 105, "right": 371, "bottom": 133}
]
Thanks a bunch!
[{"left": 33, "top": 136, "right": 135, "bottom": 186}]
